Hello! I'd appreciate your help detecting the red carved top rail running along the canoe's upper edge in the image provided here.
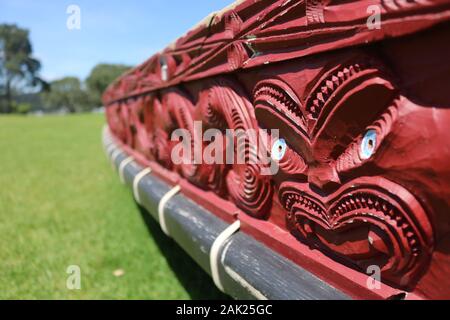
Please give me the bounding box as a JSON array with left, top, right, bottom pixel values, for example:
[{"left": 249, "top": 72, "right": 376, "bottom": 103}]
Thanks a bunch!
[{"left": 104, "top": 0, "right": 450, "bottom": 103}]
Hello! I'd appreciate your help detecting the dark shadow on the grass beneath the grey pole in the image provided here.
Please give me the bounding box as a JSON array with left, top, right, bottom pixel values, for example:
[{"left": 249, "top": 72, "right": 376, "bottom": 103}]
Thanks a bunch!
[{"left": 136, "top": 204, "right": 231, "bottom": 300}]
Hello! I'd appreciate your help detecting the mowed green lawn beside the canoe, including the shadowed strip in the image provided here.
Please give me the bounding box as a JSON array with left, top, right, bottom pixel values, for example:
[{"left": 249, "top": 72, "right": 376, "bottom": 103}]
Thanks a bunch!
[{"left": 0, "top": 114, "right": 224, "bottom": 299}]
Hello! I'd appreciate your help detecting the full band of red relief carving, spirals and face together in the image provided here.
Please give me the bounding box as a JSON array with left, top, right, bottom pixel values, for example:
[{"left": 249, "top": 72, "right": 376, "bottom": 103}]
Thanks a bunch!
[{"left": 107, "top": 55, "right": 433, "bottom": 287}]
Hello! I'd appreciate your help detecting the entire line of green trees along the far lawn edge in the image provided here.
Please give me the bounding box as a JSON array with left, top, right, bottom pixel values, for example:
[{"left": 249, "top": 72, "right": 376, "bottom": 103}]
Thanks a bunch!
[{"left": 0, "top": 24, "right": 131, "bottom": 113}]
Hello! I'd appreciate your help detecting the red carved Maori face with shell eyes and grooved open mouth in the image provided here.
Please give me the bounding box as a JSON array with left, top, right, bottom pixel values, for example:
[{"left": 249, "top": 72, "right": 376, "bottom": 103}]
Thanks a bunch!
[{"left": 254, "top": 53, "right": 450, "bottom": 287}]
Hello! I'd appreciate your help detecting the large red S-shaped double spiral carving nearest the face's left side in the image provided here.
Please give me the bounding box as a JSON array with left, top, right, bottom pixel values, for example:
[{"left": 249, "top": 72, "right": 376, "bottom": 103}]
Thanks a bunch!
[{"left": 200, "top": 79, "right": 273, "bottom": 218}]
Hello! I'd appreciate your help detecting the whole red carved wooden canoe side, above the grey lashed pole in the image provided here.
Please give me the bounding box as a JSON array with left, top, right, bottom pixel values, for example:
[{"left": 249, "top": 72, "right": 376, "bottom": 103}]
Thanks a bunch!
[{"left": 104, "top": 0, "right": 450, "bottom": 298}]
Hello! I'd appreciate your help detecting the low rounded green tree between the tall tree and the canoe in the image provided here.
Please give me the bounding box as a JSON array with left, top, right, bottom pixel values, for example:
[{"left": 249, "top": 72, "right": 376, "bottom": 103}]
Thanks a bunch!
[{"left": 42, "top": 77, "right": 92, "bottom": 113}]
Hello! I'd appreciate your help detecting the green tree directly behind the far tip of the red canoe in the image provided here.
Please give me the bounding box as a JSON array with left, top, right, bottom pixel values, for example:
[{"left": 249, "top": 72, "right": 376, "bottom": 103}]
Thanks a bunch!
[{"left": 86, "top": 63, "right": 131, "bottom": 107}]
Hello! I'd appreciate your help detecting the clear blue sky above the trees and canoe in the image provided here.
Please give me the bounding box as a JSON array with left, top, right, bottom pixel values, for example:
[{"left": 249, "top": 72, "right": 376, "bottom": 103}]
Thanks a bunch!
[{"left": 0, "top": 0, "right": 233, "bottom": 81}]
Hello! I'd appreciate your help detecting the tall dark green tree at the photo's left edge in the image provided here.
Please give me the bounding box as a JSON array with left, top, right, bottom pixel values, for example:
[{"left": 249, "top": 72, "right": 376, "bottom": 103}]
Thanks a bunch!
[{"left": 0, "top": 24, "right": 46, "bottom": 113}]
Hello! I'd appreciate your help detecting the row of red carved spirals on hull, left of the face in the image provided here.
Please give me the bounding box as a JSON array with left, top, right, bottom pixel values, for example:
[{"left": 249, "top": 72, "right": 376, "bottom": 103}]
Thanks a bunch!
[{"left": 113, "top": 78, "right": 273, "bottom": 218}]
